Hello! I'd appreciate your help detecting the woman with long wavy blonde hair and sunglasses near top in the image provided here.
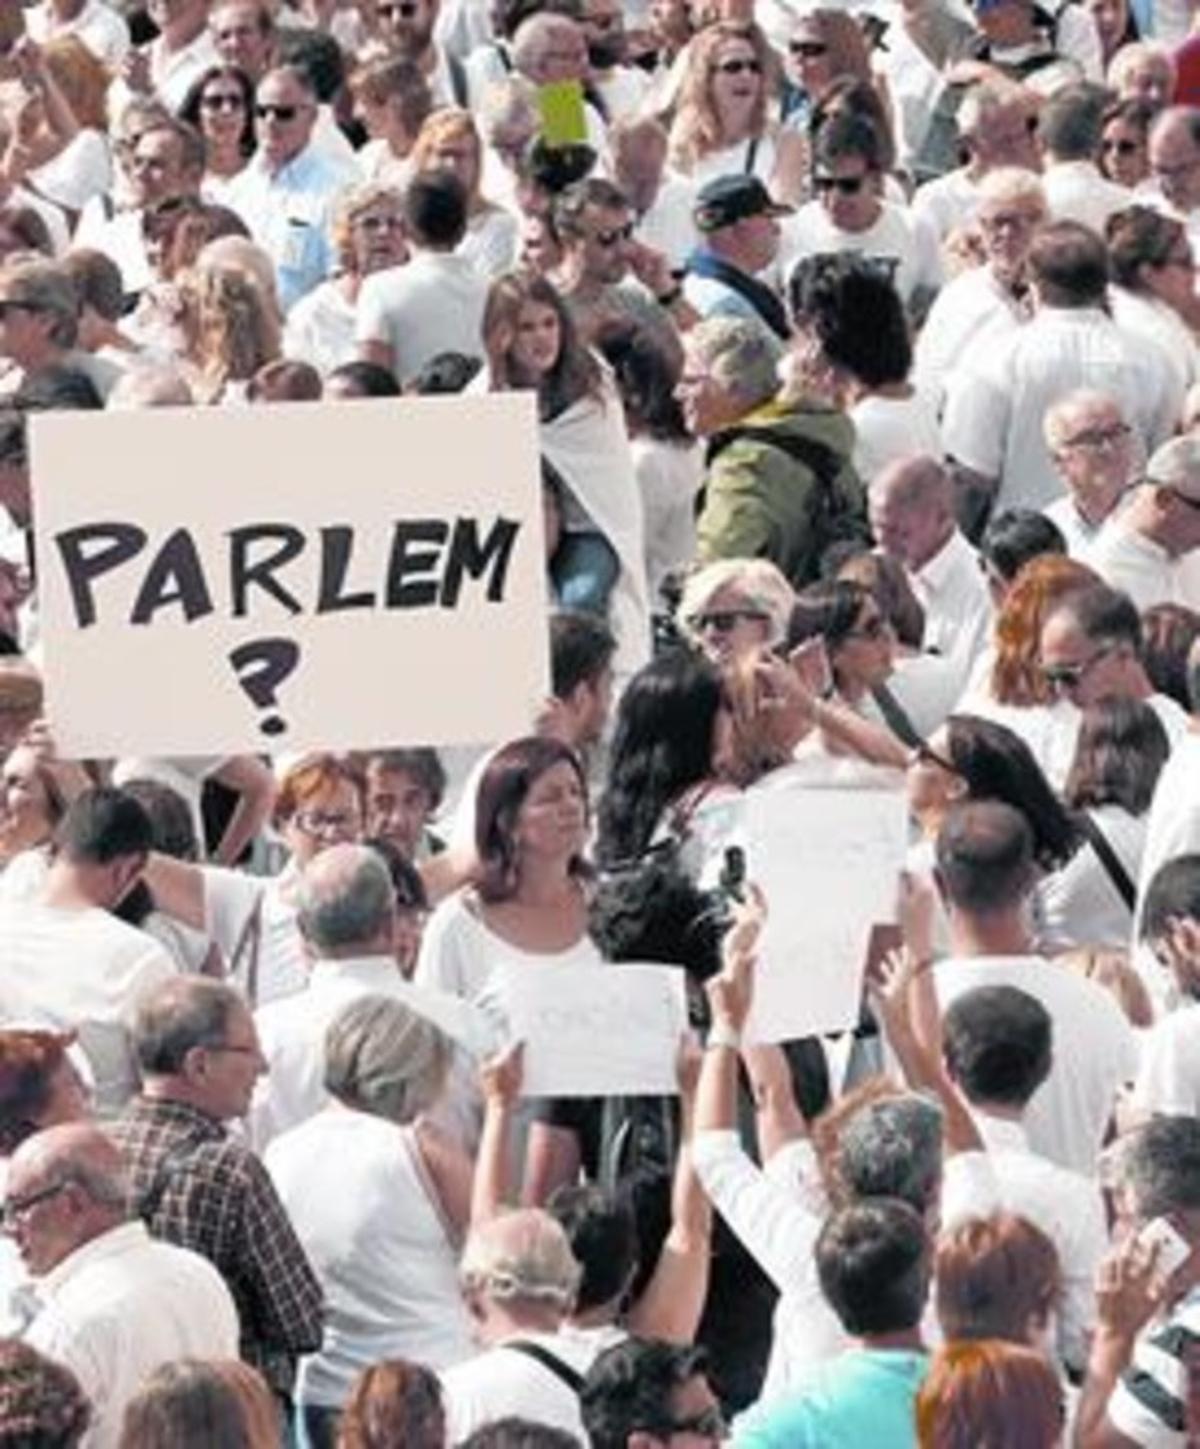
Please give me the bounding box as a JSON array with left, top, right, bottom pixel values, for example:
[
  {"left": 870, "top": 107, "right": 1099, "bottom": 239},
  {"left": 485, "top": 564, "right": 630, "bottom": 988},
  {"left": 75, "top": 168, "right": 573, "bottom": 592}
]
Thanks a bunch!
[{"left": 670, "top": 20, "right": 807, "bottom": 201}]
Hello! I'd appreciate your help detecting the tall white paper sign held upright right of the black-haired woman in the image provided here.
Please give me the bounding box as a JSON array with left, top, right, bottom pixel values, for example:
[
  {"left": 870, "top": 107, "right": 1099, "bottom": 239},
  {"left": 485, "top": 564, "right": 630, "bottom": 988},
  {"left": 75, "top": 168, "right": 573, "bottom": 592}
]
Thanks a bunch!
[{"left": 746, "top": 785, "right": 907, "bottom": 1042}]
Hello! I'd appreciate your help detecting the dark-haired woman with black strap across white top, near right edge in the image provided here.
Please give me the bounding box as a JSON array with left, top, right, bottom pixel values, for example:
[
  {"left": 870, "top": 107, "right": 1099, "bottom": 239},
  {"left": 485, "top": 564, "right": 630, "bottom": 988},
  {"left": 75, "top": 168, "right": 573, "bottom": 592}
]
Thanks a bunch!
[{"left": 1039, "top": 698, "right": 1170, "bottom": 951}]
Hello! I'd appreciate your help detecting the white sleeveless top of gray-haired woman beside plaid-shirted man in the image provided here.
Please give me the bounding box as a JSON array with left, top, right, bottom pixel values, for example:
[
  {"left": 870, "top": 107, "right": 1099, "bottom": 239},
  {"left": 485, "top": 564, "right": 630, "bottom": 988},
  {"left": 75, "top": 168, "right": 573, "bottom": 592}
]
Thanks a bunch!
[{"left": 265, "top": 1106, "right": 471, "bottom": 1407}]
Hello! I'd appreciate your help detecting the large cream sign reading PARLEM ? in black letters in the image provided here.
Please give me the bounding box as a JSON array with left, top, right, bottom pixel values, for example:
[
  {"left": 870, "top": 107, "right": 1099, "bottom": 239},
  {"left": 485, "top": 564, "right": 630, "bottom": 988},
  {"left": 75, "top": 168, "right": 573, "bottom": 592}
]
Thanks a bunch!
[{"left": 30, "top": 394, "right": 548, "bottom": 756}]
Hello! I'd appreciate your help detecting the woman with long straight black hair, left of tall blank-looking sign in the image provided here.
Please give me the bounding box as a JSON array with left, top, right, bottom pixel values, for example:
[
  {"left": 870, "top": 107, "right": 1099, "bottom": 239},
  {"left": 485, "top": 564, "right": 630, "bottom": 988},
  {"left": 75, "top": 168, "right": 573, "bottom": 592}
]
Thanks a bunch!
[{"left": 596, "top": 651, "right": 738, "bottom": 875}]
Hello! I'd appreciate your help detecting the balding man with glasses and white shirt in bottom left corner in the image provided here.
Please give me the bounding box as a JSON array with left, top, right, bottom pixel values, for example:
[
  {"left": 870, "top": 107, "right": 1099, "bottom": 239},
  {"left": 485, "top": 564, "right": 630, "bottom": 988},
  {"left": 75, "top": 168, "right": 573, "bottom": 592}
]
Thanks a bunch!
[{"left": 3, "top": 1123, "right": 238, "bottom": 1449}]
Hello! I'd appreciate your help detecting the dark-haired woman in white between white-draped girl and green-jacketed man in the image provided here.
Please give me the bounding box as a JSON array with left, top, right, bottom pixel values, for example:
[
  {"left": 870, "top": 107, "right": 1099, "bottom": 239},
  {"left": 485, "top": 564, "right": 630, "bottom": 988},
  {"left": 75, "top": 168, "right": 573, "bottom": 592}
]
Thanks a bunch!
[{"left": 597, "top": 327, "right": 704, "bottom": 606}]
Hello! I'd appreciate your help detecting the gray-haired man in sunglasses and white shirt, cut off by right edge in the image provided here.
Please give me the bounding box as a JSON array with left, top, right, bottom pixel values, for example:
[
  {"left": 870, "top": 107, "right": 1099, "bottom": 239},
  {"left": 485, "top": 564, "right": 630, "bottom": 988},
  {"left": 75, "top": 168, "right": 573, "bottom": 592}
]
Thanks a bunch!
[{"left": 1084, "top": 433, "right": 1200, "bottom": 611}]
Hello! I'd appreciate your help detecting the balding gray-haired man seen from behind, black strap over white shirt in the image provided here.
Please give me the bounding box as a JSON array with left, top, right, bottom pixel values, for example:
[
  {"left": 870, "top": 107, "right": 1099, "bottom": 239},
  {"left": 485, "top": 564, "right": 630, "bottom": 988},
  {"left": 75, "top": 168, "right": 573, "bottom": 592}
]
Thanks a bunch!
[{"left": 442, "top": 1208, "right": 596, "bottom": 1445}]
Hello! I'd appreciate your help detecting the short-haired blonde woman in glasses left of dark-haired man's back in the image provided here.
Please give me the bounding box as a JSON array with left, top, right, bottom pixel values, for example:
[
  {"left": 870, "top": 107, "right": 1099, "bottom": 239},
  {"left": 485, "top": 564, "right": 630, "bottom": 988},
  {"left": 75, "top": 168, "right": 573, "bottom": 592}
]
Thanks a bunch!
[{"left": 283, "top": 181, "right": 409, "bottom": 372}]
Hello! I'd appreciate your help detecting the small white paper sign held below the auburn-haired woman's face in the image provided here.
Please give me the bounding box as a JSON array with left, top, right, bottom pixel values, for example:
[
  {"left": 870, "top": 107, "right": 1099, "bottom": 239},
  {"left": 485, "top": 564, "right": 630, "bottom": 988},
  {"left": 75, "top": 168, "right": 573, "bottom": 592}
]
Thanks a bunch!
[{"left": 496, "top": 964, "right": 687, "bottom": 1097}]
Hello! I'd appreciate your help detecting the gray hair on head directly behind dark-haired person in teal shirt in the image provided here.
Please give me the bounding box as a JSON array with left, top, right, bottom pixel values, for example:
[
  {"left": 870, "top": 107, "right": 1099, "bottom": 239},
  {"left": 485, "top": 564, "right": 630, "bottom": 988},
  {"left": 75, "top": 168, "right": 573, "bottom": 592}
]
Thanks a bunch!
[{"left": 838, "top": 1093, "right": 942, "bottom": 1213}]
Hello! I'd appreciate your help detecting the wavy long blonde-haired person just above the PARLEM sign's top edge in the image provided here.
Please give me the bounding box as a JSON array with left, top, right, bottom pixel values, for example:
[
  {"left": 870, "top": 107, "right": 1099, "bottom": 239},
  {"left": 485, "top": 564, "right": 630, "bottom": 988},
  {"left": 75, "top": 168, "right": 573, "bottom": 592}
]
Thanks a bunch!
[{"left": 180, "top": 257, "right": 280, "bottom": 403}]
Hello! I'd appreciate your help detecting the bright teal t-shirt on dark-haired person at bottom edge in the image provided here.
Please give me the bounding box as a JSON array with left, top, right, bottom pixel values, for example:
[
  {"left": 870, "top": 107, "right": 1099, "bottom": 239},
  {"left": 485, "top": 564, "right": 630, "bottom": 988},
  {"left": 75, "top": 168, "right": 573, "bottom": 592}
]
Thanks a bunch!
[{"left": 733, "top": 1349, "right": 929, "bottom": 1449}]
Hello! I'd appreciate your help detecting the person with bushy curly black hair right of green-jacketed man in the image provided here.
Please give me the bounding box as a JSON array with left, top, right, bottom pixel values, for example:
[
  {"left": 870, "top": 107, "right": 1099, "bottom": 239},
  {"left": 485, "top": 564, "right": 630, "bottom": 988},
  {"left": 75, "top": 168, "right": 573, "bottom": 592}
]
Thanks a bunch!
[{"left": 791, "top": 256, "right": 942, "bottom": 483}]
